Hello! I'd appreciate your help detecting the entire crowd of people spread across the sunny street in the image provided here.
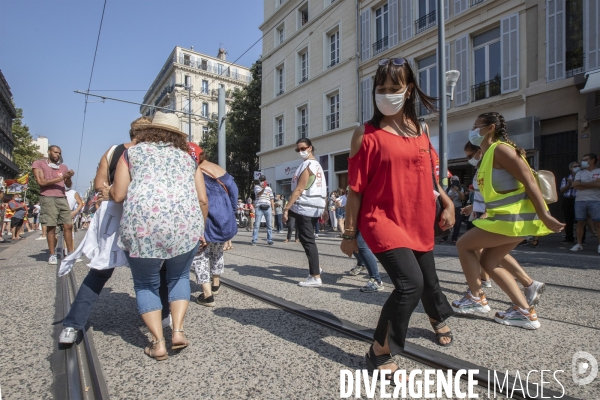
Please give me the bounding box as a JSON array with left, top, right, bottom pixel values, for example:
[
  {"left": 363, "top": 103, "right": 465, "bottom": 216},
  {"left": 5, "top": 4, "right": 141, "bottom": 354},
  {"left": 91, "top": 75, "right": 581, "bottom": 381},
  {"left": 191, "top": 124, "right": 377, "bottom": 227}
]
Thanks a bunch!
[{"left": 9, "top": 58, "right": 600, "bottom": 373}]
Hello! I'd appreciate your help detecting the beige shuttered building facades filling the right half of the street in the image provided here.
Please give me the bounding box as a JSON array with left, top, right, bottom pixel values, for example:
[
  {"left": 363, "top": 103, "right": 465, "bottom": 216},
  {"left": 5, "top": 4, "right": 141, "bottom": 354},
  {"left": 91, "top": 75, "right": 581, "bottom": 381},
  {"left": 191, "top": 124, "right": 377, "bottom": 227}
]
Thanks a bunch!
[{"left": 259, "top": 0, "right": 600, "bottom": 219}]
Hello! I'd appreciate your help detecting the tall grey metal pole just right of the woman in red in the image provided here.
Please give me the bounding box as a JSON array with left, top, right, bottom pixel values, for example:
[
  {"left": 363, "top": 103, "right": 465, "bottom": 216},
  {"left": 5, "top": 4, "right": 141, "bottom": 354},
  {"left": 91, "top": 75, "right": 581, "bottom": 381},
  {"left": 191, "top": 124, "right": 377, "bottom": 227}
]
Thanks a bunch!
[{"left": 437, "top": 0, "right": 448, "bottom": 189}]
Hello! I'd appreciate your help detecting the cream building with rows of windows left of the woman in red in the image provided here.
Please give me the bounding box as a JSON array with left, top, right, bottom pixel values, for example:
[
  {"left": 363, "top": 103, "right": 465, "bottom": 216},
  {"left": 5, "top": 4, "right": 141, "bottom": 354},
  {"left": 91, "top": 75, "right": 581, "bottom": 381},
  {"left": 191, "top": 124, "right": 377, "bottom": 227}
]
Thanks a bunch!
[{"left": 259, "top": 0, "right": 359, "bottom": 195}]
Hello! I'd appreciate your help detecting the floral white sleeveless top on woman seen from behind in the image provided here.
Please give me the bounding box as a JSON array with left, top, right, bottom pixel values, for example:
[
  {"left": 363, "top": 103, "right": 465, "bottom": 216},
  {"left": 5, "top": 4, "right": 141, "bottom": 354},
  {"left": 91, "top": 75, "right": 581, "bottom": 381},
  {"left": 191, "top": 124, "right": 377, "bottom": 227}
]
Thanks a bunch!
[{"left": 118, "top": 143, "right": 204, "bottom": 259}]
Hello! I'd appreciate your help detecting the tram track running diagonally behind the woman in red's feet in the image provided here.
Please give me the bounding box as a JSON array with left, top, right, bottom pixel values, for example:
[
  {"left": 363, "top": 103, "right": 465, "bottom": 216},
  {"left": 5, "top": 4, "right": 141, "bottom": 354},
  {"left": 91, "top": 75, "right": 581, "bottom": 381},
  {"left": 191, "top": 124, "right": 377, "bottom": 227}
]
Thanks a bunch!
[{"left": 221, "top": 278, "right": 575, "bottom": 400}]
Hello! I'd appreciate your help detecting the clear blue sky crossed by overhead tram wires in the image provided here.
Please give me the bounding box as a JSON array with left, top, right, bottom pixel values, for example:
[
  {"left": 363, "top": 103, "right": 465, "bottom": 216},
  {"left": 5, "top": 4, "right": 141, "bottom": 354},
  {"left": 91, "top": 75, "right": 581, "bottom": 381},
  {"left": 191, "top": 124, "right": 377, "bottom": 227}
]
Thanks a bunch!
[{"left": 0, "top": 0, "right": 264, "bottom": 193}]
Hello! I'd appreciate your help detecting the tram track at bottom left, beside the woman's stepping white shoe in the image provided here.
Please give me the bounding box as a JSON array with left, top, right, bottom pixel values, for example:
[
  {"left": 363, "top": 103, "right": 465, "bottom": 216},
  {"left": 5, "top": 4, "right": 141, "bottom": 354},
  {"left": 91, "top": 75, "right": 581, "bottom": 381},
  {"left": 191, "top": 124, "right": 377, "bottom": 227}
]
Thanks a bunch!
[{"left": 51, "top": 234, "right": 109, "bottom": 400}]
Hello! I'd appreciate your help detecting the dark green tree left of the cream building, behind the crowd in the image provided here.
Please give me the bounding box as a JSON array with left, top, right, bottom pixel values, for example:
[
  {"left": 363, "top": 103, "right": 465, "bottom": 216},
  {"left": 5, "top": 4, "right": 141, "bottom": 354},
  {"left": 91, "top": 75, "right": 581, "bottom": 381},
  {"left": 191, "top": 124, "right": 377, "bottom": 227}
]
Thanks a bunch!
[{"left": 200, "top": 60, "right": 262, "bottom": 199}]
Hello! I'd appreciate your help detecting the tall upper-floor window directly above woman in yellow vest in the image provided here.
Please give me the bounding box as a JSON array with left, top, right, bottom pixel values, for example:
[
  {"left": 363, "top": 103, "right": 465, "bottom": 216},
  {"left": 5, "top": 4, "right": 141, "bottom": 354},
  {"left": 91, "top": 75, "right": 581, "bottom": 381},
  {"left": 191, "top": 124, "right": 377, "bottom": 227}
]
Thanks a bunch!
[{"left": 471, "top": 27, "right": 502, "bottom": 101}]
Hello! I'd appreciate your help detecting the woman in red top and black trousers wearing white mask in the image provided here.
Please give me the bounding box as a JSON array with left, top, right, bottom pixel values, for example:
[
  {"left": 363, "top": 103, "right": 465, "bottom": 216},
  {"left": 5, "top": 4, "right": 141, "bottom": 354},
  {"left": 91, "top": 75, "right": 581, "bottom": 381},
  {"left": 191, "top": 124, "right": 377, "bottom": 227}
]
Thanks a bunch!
[{"left": 341, "top": 58, "right": 454, "bottom": 382}]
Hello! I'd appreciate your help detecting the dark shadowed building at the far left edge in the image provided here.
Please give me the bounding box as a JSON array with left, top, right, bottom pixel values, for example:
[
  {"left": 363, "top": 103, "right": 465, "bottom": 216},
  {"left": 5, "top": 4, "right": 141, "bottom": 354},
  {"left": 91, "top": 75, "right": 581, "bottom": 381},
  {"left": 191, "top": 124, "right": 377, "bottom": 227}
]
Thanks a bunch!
[{"left": 0, "top": 71, "right": 19, "bottom": 179}]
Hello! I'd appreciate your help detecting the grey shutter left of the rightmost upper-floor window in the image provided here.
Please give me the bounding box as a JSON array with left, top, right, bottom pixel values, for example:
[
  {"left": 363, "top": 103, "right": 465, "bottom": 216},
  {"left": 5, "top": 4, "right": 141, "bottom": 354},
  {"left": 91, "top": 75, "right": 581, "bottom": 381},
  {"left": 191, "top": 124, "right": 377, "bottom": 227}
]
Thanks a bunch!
[{"left": 546, "top": 0, "right": 565, "bottom": 82}]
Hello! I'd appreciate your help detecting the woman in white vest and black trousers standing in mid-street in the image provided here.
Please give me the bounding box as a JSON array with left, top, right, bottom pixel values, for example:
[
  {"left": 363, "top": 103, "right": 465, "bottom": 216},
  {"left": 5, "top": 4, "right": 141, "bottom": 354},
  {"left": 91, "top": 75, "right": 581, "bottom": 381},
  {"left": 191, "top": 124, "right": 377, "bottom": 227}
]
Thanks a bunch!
[{"left": 283, "top": 138, "right": 329, "bottom": 287}]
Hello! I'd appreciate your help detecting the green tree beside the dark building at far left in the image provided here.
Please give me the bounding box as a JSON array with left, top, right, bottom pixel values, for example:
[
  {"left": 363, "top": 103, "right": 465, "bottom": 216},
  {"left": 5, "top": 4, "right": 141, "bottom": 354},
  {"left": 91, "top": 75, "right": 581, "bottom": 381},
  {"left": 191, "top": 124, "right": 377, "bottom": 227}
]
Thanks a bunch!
[{"left": 13, "top": 108, "right": 43, "bottom": 202}]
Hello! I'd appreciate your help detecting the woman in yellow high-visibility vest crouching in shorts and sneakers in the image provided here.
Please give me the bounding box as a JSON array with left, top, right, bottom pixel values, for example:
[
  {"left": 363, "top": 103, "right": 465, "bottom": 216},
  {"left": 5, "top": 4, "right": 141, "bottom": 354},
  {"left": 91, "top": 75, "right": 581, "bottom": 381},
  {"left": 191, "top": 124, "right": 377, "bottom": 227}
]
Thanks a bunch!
[{"left": 452, "top": 112, "right": 564, "bottom": 329}]
